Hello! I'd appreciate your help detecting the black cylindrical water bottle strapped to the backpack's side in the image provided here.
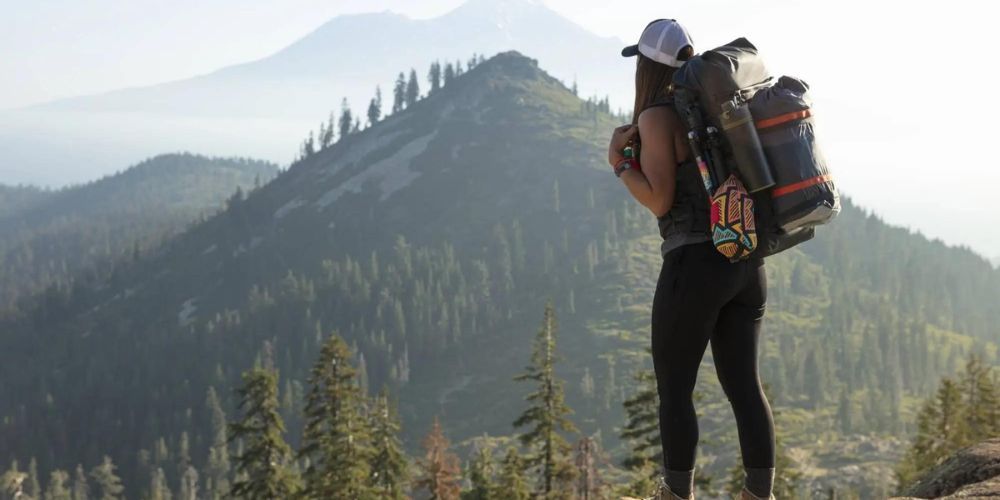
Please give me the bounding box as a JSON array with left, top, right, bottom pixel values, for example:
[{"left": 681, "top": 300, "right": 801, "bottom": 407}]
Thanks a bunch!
[{"left": 719, "top": 100, "right": 774, "bottom": 193}]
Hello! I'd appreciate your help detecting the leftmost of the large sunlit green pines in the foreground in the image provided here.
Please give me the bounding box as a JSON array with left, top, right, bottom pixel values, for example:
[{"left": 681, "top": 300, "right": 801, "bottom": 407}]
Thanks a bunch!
[{"left": 229, "top": 368, "right": 299, "bottom": 500}]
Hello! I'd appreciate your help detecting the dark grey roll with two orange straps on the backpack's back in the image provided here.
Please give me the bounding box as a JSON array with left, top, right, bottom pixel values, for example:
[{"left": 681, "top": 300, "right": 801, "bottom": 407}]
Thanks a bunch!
[{"left": 750, "top": 76, "right": 840, "bottom": 233}]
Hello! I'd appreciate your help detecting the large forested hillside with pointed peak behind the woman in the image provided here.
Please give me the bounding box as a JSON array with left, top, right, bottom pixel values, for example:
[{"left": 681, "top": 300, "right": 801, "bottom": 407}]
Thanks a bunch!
[{"left": 0, "top": 52, "right": 1000, "bottom": 495}]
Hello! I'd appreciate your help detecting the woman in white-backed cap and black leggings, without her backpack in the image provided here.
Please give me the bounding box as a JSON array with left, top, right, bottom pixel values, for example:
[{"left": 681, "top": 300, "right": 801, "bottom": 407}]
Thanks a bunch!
[{"left": 608, "top": 19, "right": 774, "bottom": 500}]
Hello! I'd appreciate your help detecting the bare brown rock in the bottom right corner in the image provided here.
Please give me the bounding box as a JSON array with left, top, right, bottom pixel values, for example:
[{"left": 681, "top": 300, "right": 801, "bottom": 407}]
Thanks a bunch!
[{"left": 897, "top": 438, "right": 1000, "bottom": 500}]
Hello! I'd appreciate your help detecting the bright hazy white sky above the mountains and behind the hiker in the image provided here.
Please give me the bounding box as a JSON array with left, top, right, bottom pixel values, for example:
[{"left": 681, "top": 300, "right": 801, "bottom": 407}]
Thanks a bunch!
[{"left": 0, "top": 0, "right": 1000, "bottom": 255}]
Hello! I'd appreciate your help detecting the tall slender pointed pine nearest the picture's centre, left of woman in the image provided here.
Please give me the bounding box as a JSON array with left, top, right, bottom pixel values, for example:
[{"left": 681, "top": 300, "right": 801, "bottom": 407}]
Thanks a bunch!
[{"left": 514, "top": 300, "right": 577, "bottom": 498}]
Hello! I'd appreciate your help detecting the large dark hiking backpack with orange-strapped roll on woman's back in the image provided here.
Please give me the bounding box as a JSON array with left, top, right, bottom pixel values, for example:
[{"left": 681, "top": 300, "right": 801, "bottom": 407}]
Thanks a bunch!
[{"left": 673, "top": 38, "right": 840, "bottom": 257}]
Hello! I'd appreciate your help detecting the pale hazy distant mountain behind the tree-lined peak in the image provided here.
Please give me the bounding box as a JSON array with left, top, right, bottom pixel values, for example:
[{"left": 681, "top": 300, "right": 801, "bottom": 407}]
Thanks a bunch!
[{"left": 0, "top": 0, "right": 634, "bottom": 186}]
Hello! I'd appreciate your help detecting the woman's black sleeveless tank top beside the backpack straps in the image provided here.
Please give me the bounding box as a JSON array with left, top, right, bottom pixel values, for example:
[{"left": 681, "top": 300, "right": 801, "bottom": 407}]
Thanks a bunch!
[{"left": 645, "top": 98, "right": 712, "bottom": 256}]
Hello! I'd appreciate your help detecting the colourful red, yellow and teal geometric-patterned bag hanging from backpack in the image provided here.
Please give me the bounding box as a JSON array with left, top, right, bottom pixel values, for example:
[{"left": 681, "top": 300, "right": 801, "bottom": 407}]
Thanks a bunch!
[{"left": 712, "top": 175, "right": 757, "bottom": 262}]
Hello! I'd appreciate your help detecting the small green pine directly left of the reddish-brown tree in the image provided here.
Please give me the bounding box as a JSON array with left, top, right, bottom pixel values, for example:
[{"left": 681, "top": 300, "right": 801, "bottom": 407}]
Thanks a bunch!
[{"left": 371, "top": 387, "right": 409, "bottom": 500}]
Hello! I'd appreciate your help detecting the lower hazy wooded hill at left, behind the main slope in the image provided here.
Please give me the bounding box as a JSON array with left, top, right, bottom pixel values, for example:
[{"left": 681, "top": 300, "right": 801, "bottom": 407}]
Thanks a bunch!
[{"left": 0, "top": 154, "right": 277, "bottom": 310}]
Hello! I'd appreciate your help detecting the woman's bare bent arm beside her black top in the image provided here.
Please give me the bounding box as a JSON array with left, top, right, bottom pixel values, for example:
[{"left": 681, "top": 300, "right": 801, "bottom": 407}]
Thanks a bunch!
[{"left": 621, "top": 106, "right": 681, "bottom": 217}]
